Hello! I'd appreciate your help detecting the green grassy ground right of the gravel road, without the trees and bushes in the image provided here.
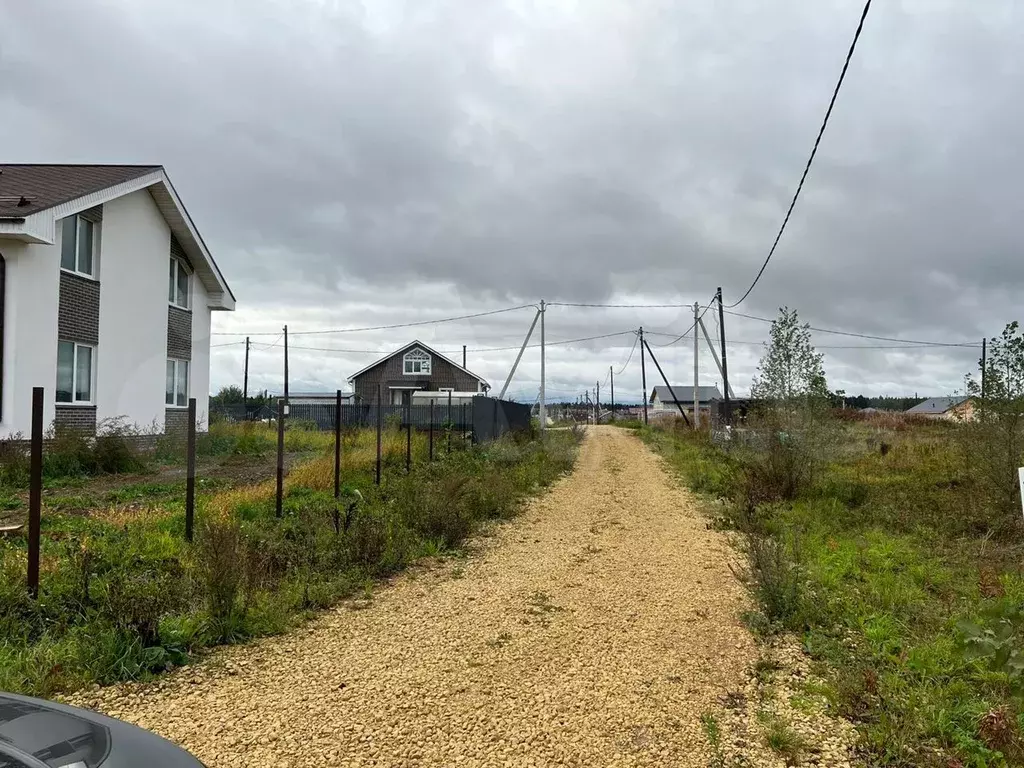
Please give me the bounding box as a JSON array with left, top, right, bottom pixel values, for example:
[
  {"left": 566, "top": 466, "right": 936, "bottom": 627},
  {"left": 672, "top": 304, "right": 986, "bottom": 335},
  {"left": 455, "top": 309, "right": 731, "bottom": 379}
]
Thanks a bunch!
[{"left": 639, "top": 422, "right": 1024, "bottom": 768}]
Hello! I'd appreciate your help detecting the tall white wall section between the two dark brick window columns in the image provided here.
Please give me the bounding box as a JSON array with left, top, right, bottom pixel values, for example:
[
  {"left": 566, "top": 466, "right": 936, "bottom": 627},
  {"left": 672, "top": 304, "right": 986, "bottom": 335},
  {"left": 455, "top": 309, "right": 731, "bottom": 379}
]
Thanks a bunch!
[{"left": 96, "top": 189, "right": 171, "bottom": 430}]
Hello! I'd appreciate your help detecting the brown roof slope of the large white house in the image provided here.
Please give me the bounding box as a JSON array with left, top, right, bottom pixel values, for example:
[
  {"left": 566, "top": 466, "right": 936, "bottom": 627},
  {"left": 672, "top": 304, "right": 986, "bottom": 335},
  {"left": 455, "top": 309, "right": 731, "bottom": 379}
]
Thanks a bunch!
[{"left": 0, "top": 165, "right": 161, "bottom": 218}]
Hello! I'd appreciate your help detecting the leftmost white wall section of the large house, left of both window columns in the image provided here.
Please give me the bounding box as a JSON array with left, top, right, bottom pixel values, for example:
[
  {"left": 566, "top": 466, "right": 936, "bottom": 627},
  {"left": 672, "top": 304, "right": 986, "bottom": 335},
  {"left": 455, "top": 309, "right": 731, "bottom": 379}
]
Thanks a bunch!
[{"left": 0, "top": 238, "right": 60, "bottom": 437}]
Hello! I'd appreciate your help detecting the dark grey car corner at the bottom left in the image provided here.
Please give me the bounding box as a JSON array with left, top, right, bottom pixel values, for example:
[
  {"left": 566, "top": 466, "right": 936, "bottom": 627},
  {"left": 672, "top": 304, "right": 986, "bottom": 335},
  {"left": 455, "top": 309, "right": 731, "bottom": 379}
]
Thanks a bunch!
[{"left": 0, "top": 692, "right": 204, "bottom": 768}]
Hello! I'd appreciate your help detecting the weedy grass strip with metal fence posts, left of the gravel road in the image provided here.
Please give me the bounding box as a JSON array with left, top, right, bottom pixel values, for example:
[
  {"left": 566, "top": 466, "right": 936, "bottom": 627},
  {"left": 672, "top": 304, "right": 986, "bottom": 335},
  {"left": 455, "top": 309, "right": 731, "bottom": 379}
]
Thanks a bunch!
[{"left": 0, "top": 425, "right": 577, "bottom": 695}]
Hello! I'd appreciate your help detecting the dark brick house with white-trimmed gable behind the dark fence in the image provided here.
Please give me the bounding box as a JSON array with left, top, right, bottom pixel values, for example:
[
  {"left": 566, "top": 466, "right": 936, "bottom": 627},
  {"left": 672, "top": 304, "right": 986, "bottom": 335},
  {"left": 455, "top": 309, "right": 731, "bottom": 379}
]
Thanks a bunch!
[{"left": 348, "top": 341, "right": 490, "bottom": 404}]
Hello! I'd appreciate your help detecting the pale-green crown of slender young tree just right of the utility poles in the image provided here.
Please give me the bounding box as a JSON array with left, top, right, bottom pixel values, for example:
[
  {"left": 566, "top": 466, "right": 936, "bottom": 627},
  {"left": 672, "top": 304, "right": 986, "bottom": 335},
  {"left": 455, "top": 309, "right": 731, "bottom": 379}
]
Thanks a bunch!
[{"left": 751, "top": 307, "right": 828, "bottom": 406}]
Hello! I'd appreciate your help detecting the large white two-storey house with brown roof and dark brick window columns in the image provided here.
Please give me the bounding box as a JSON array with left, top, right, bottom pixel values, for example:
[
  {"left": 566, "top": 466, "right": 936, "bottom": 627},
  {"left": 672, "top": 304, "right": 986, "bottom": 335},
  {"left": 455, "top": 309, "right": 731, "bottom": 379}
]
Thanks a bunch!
[{"left": 0, "top": 165, "right": 234, "bottom": 437}]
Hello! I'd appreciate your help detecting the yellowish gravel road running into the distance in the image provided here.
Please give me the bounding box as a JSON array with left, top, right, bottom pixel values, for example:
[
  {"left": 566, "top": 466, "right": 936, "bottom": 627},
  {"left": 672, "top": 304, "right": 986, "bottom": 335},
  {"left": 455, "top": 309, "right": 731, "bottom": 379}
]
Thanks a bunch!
[{"left": 70, "top": 427, "right": 770, "bottom": 768}]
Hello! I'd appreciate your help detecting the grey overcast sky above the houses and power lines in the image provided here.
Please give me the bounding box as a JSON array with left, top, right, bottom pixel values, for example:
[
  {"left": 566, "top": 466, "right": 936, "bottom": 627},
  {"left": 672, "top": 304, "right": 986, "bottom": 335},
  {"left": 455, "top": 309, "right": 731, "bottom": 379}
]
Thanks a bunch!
[{"left": 0, "top": 0, "right": 1024, "bottom": 400}]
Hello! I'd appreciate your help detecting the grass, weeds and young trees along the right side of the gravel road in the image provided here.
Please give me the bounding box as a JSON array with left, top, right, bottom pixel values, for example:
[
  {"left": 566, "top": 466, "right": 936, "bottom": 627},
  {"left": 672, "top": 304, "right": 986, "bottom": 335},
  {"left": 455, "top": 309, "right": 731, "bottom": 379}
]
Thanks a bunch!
[{"left": 639, "top": 310, "right": 1024, "bottom": 768}]
